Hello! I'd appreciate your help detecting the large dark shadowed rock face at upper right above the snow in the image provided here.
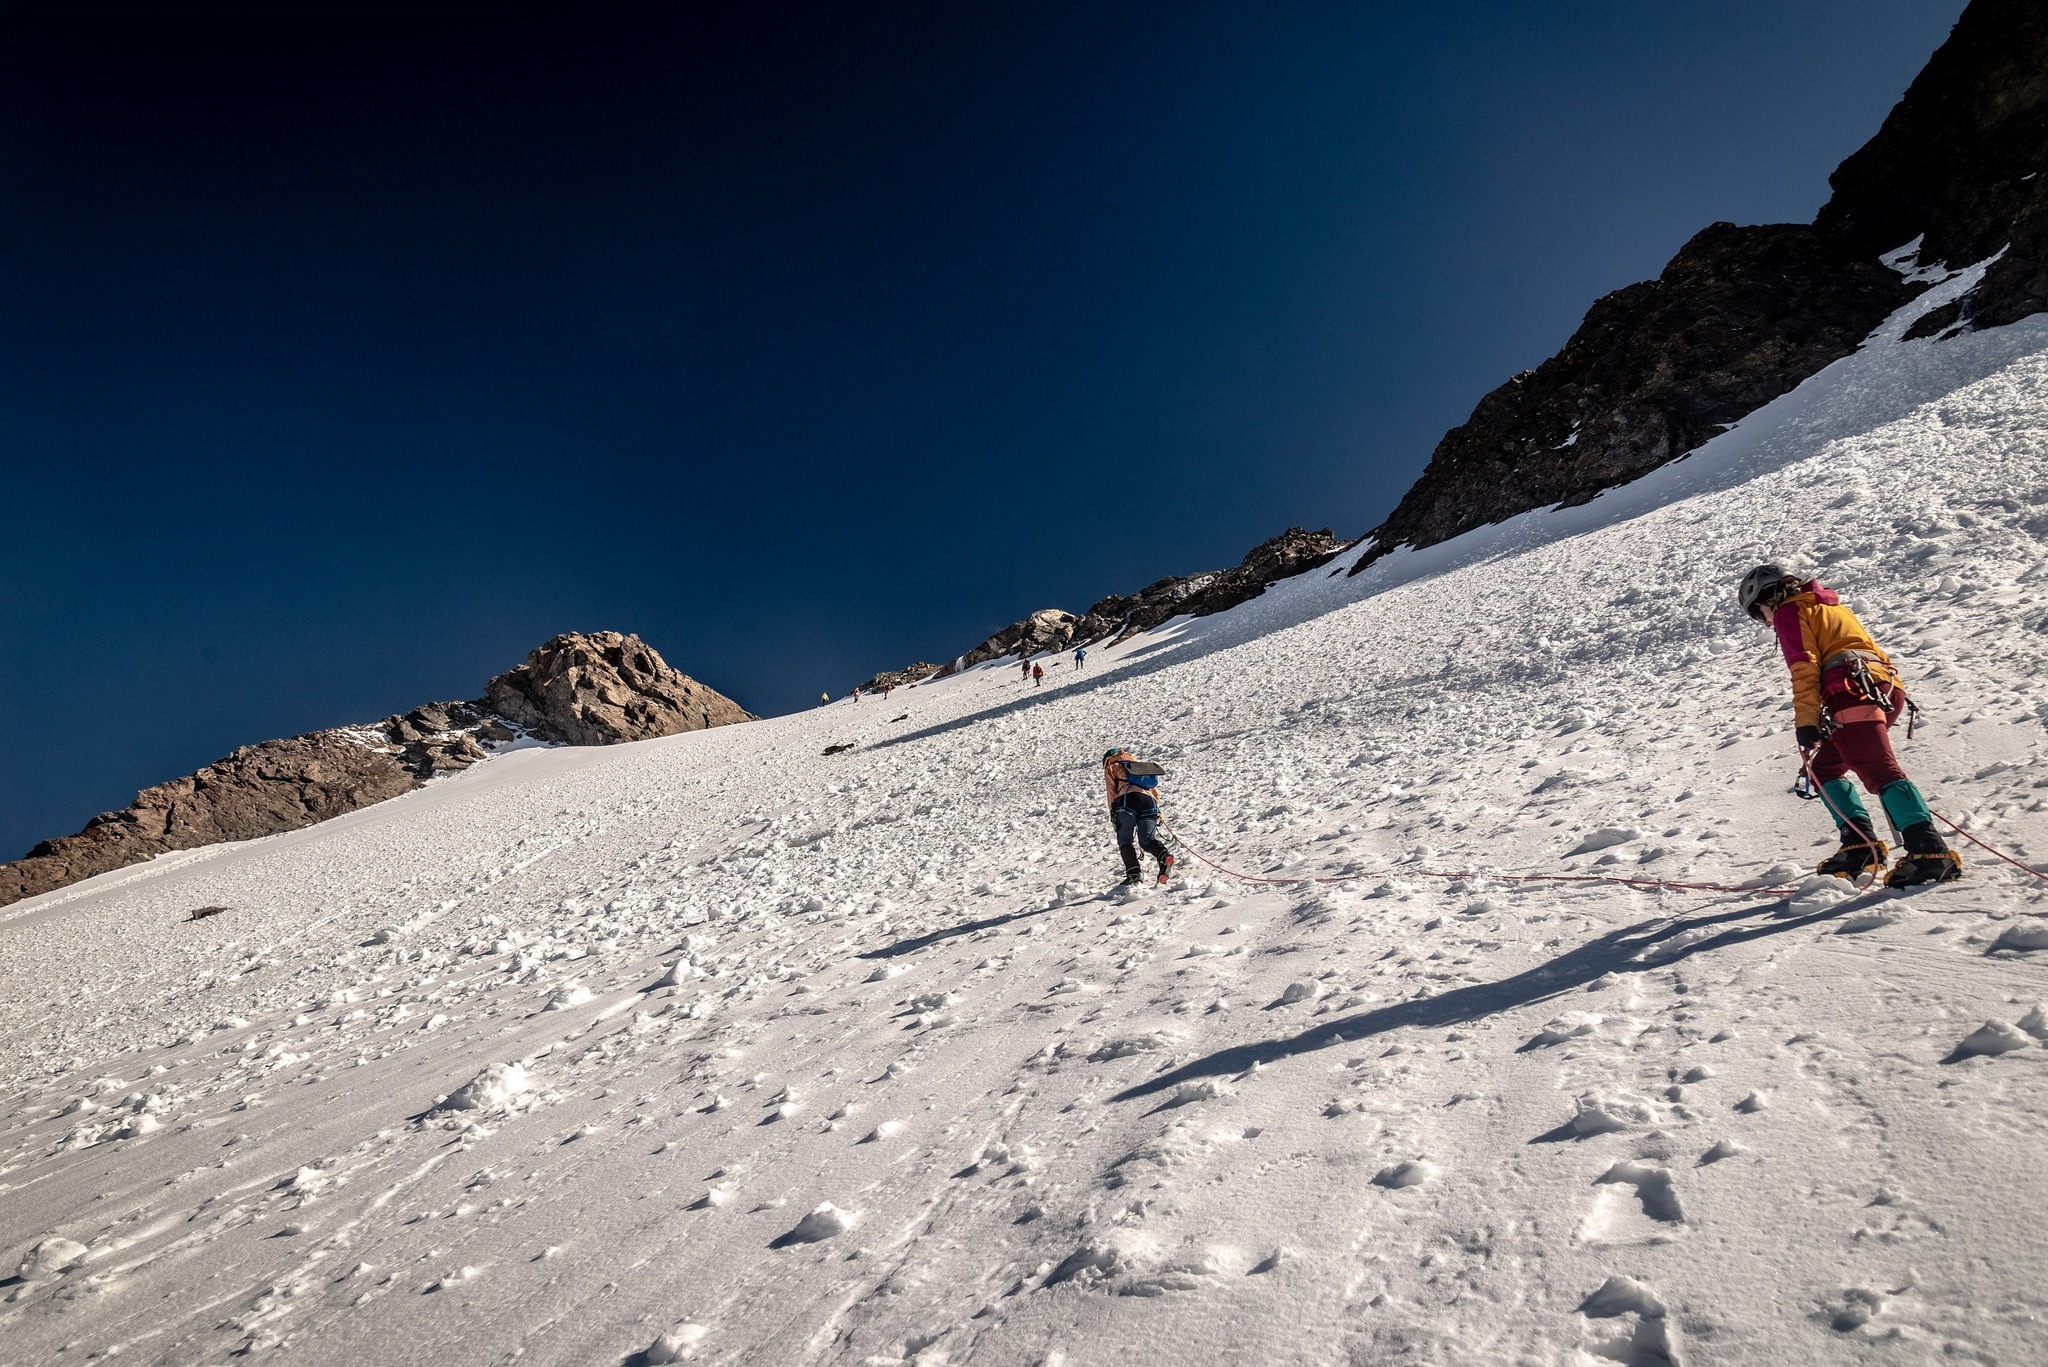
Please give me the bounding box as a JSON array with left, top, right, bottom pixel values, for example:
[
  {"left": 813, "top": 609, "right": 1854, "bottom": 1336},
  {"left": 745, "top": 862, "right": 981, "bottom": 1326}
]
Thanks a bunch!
[{"left": 1358, "top": 0, "right": 2048, "bottom": 568}]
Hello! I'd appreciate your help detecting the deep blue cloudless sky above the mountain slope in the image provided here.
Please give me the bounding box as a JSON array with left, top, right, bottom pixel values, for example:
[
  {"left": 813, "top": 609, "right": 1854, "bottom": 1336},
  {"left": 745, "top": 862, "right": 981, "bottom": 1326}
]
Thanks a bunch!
[{"left": 0, "top": 0, "right": 1962, "bottom": 857}]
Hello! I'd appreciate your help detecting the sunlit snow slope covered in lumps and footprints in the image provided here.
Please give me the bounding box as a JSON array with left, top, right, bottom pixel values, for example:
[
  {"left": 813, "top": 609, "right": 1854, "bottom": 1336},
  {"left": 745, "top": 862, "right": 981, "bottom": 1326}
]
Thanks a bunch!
[{"left": 0, "top": 299, "right": 2048, "bottom": 1367}]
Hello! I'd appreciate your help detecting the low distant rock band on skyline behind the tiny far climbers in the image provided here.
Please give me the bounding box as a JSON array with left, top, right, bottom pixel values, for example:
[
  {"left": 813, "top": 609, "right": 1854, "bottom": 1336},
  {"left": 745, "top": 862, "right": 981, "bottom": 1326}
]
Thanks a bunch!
[{"left": 860, "top": 527, "right": 1346, "bottom": 693}]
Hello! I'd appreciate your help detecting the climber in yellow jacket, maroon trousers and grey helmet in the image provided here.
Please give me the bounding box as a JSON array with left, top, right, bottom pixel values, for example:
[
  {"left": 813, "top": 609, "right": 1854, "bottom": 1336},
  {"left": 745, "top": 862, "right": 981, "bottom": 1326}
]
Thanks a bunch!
[{"left": 1737, "top": 566, "right": 1962, "bottom": 887}]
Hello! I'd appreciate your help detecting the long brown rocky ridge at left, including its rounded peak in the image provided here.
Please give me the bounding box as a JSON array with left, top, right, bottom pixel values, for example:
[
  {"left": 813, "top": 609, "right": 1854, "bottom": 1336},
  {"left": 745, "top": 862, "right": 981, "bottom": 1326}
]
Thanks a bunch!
[{"left": 0, "top": 631, "right": 750, "bottom": 906}]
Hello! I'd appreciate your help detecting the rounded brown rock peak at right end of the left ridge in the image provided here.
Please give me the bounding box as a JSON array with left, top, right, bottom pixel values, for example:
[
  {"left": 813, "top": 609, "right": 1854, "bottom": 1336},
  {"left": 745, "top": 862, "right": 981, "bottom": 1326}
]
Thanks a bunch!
[{"left": 481, "top": 631, "right": 754, "bottom": 746}]
